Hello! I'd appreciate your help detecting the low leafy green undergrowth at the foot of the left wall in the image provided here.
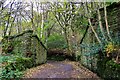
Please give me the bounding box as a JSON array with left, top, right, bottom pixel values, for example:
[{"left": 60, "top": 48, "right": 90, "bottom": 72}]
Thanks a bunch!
[{"left": 0, "top": 56, "right": 33, "bottom": 78}]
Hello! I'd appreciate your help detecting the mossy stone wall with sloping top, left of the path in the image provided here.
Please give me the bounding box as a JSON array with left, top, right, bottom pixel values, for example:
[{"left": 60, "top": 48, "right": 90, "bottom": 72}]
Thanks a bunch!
[{"left": 2, "top": 30, "right": 47, "bottom": 65}]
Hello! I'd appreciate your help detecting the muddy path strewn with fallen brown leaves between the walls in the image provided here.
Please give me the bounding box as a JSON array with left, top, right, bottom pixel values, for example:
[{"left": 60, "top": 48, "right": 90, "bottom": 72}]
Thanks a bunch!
[{"left": 24, "top": 61, "right": 99, "bottom": 80}]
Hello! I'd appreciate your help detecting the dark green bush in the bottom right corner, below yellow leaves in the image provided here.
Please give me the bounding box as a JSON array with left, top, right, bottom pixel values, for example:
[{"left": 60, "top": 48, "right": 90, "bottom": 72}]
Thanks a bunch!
[{"left": 97, "top": 58, "right": 120, "bottom": 80}]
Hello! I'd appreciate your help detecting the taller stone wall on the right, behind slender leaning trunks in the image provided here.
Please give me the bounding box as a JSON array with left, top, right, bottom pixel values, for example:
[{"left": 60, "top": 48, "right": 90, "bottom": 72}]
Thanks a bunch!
[{"left": 79, "top": 2, "right": 120, "bottom": 70}]
